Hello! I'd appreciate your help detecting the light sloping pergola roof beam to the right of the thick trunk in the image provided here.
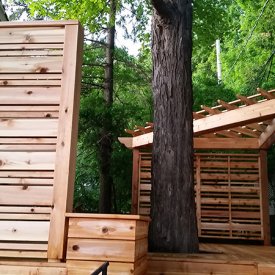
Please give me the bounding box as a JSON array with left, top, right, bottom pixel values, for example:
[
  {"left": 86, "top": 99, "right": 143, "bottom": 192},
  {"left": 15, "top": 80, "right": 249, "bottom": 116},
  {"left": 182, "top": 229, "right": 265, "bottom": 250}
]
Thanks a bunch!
[{"left": 193, "top": 100, "right": 275, "bottom": 136}]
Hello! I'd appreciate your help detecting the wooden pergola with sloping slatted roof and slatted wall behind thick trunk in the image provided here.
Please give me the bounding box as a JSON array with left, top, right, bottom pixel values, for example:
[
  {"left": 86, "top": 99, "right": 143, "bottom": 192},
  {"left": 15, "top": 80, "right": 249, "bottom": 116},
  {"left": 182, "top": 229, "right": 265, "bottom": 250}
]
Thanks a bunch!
[{"left": 119, "top": 88, "right": 275, "bottom": 244}]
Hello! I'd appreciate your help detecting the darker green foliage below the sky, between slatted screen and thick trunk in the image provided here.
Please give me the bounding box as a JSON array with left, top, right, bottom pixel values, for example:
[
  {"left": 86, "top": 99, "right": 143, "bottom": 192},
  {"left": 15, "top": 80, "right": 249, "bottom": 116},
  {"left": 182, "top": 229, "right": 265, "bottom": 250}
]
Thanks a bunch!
[{"left": 75, "top": 45, "right": 152, "bottom": 213}]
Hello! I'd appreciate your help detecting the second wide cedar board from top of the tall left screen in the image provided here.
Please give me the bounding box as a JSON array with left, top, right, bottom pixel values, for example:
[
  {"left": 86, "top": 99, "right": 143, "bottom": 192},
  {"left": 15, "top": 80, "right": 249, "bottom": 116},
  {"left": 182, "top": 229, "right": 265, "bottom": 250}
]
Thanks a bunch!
[{"left": 0, "top": 56, "right": 62, "bottom": 73}]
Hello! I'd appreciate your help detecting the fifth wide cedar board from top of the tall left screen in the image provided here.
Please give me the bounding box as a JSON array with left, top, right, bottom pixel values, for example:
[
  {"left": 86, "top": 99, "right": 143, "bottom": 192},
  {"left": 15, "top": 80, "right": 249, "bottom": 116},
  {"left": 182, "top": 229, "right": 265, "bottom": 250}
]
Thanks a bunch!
[{"left": 0, "top": 152, "right": 55, "bottom": 170}]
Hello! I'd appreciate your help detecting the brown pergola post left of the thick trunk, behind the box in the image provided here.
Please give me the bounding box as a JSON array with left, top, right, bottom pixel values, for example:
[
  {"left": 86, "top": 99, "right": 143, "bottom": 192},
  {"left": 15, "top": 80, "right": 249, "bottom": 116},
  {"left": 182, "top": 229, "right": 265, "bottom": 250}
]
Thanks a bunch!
[{"left": 131, "top": 149, "right": 139, "bottom": 214}]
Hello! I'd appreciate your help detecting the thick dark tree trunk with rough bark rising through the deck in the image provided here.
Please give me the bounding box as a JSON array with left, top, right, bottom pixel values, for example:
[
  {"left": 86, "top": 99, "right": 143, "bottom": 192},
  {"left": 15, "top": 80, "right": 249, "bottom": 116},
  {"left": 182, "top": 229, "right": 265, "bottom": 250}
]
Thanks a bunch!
[{"left": 149, "top": 0, "right": 198, "bottom": 253}]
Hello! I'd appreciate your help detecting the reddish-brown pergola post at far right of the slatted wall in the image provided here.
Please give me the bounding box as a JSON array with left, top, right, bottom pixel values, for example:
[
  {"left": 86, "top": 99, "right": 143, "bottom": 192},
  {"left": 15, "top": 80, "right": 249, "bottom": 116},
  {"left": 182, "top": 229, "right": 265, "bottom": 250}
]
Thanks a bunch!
[{"left": 260, "top": 150, "right": 271, "bottom": 245}]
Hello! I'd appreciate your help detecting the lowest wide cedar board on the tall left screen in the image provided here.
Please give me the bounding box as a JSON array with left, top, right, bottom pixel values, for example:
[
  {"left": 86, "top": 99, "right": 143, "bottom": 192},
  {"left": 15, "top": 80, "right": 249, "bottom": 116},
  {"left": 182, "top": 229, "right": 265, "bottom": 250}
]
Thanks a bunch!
[{"left": 0, "top": 221, "right": 50, "bottom": 242}]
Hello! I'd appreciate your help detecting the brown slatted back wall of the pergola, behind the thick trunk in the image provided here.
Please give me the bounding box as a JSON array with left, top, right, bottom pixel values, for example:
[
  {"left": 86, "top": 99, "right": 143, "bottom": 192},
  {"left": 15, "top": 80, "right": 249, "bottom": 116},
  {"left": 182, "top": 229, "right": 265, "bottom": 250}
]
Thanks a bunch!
[{"left": 138, "top": 152, "right": 264, "bottom": 240}]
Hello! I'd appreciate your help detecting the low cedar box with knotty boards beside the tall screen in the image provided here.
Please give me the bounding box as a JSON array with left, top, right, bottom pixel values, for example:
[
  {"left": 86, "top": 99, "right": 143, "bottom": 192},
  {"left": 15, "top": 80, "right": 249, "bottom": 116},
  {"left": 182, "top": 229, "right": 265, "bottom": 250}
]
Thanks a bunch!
[{"left": 66, "top": 214, "right": 149, "bottom": 274}]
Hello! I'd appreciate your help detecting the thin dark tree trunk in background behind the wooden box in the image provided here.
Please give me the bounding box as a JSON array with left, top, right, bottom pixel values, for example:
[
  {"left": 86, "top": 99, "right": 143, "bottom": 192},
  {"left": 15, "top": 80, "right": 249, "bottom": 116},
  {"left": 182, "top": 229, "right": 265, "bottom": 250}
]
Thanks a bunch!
[{"left": 99, "top": 0, "right": 116, "bottom": 213}]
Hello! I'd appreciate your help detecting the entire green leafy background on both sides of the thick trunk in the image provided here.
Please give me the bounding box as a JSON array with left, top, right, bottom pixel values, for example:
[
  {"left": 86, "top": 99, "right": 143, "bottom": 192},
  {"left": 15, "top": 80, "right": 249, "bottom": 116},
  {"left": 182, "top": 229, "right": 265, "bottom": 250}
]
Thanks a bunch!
[{"left": 9, "top": 0, "right": 275, "bottom": 213}]
